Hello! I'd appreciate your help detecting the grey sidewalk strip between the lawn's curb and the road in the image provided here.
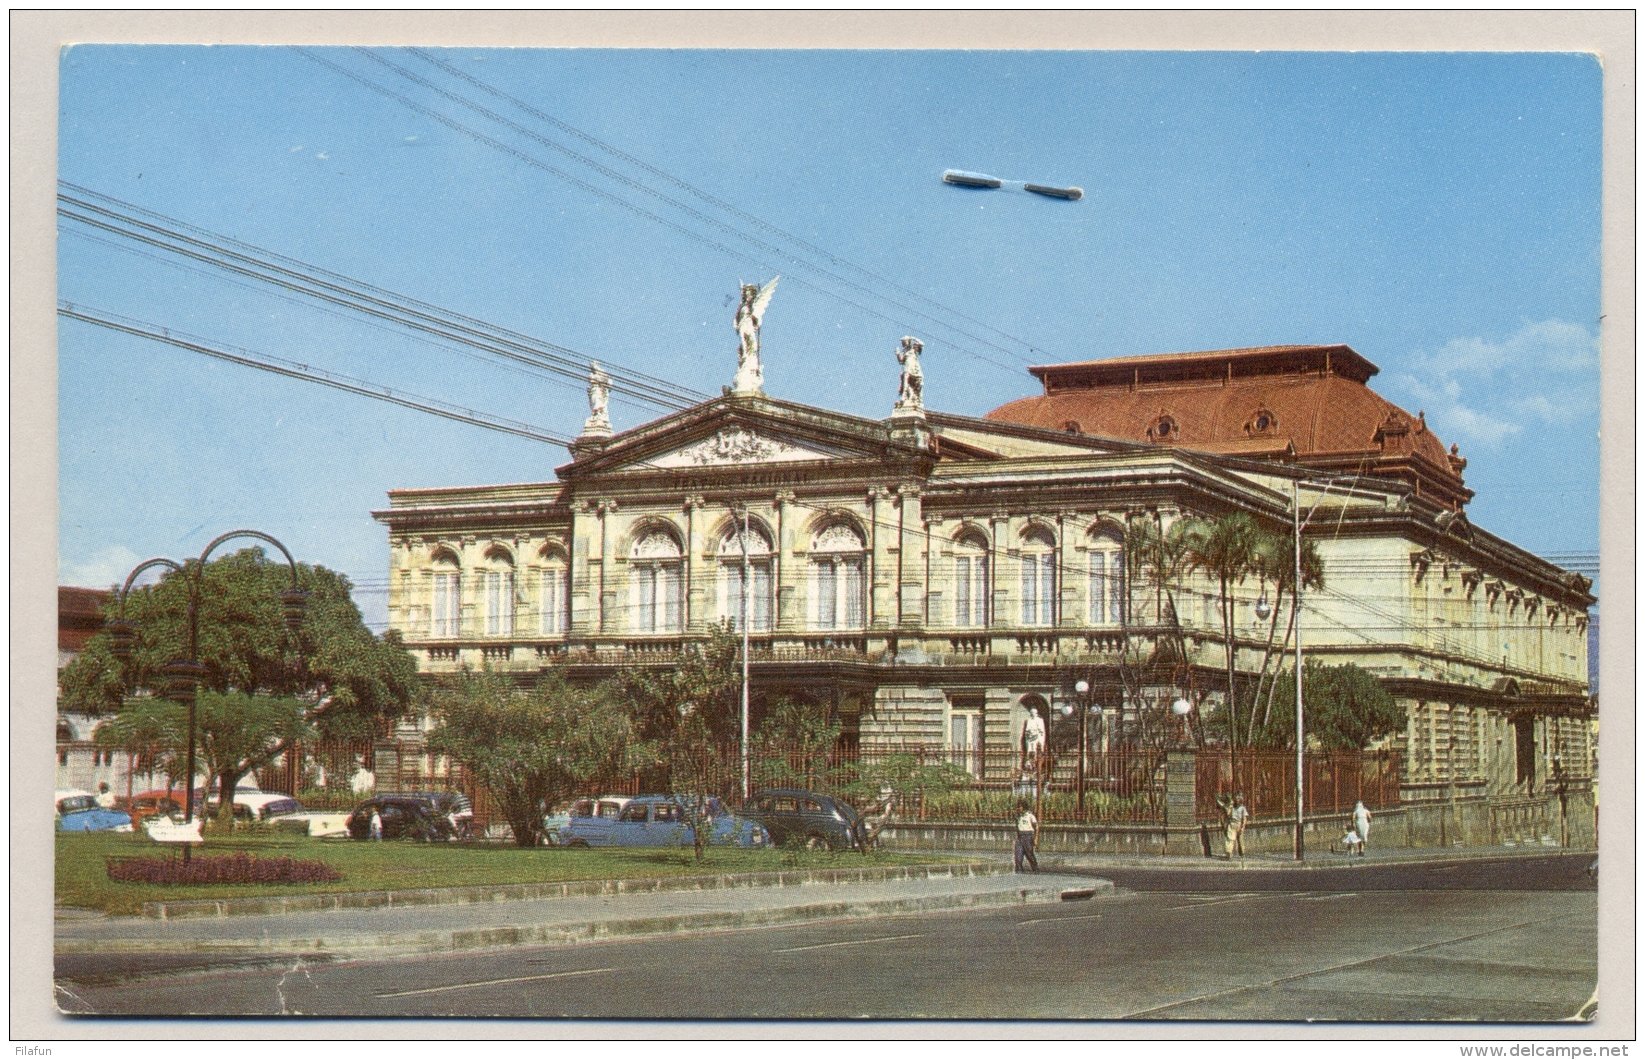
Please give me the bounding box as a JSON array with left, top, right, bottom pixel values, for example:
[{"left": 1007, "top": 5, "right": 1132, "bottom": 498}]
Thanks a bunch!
[{"left": 56, "top": 872, "right": 1114, "bottom": 958}]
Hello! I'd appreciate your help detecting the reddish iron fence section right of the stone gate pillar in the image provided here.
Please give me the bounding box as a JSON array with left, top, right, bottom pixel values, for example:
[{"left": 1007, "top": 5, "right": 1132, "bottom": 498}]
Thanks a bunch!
[{"left": 1194, "top": 751, "right": 1400, "bottom": 821}]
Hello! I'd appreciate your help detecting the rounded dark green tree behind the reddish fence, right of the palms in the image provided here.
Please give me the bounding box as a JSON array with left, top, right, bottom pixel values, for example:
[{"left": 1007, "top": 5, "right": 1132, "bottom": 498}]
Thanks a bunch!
[{"left": 1255, "top": 662, "right": 1405, "bottom": 751}]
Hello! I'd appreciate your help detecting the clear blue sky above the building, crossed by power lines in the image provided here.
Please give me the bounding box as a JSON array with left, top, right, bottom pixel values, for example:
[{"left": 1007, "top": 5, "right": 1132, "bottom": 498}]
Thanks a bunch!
[{"left": 58, "top": 46, "right": 1601, "bottom": 621}]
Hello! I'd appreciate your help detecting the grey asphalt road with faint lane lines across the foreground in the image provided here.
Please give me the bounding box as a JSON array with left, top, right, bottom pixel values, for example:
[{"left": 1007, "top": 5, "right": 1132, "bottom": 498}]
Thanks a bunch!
[{"left": 58, "top": 858, "right": 1597, "bottom": 1020}]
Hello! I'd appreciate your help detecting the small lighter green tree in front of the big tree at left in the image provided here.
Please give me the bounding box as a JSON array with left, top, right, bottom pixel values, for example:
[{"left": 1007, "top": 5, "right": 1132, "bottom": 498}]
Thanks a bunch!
[{"left": 94, "top": 691, "right": 314, "bottom": 820}]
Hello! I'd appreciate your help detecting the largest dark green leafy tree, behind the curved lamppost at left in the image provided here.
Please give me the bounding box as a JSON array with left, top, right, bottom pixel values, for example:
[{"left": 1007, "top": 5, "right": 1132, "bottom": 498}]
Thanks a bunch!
[{"left": 59, "top": 548, "right": 418, "bottom": 805}]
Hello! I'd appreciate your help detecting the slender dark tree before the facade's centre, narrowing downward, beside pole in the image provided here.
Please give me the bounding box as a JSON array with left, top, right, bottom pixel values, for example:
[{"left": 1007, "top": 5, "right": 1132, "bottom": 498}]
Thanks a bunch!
[{"left": 615, "top": 621, "right": 742, "bottom": 858}]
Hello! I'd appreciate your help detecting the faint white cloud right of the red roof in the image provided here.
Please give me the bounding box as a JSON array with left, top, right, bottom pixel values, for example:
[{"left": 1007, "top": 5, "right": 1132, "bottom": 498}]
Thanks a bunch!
[{"left": 1395, "top": 319, "right": 1599, "bottom": 448}]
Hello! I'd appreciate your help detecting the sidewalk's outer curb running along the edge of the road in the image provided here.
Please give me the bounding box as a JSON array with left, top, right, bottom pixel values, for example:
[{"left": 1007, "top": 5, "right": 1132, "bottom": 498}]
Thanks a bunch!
[{"left": 67, "top": 881, "right": 1114, "bottom": 956}]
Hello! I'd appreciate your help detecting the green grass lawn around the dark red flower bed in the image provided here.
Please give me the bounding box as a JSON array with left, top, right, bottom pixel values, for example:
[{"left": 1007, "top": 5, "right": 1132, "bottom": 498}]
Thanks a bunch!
[{"left": 56, "top": 831, "right": 972, "bottom": 914}]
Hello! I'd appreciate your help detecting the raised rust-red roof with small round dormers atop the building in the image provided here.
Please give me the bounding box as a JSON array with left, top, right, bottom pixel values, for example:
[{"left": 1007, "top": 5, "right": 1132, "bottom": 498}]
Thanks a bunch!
[{"left": 987, "top": 346, "right": 1471, "bottom": 502}]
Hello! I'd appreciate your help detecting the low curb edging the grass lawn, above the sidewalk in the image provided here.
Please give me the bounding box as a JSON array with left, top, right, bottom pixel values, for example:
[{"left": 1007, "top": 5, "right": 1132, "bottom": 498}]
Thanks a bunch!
[{"left": 141, "top": 864, "right": 1010, "bottom": 920}]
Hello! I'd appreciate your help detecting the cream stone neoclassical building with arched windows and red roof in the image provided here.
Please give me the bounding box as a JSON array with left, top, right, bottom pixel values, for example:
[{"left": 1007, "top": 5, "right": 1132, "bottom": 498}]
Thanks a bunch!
[{"left": 375, "top": 339, "right": 1594, "bottom": 795}]
